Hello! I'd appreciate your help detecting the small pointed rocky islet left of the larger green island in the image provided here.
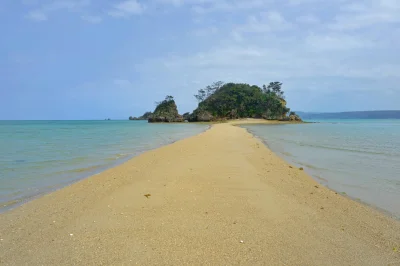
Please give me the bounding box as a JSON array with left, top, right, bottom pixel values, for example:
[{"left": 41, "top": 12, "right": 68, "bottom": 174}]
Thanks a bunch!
[{"left": 148, "top": 95, "right": 184, "bottom": 123}]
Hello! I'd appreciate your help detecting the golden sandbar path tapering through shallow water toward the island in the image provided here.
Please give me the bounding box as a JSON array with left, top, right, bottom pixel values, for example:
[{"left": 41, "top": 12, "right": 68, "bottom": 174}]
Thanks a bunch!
[{"left": 0, "top": 120, "right": 400, "bottom": 265}]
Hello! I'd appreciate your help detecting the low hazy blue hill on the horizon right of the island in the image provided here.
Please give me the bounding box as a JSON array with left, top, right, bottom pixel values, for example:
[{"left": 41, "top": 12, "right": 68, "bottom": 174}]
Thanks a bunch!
[{"left": 296, "top": 110, "right": 400, "bottom": 120}]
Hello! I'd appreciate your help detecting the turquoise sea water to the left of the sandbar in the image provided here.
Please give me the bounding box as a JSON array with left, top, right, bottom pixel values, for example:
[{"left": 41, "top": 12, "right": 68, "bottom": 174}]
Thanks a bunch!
[{"left": 0, "top": 121, "right": 207, "bottom": 210}]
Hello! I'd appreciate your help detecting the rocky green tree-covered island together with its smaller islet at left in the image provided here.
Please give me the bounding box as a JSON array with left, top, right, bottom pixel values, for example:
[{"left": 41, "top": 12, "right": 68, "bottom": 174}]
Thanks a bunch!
[{"left": 132, "top": 81, "right": 301, "bottom": 122}]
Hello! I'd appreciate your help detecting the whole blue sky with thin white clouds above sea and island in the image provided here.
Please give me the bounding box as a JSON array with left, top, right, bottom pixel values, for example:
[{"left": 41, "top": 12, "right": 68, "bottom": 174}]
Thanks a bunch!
[{"left": 0, "top": 0, "right": 400, "bottom": 119}]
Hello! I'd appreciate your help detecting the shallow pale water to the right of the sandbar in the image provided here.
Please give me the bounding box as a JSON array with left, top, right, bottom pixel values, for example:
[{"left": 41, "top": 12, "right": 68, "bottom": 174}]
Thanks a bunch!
[{"left": 244, "top": 120, "right": 400, "bottom": 217}]
